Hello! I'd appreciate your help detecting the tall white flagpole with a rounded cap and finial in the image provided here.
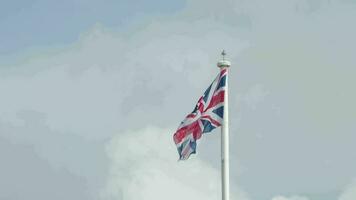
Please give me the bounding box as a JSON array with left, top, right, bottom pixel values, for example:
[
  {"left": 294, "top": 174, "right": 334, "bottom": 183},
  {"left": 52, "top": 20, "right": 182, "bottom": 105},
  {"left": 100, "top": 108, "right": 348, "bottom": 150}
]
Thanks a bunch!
[{"left": 218, "top": 51, "right": 231, "bottom": 200}]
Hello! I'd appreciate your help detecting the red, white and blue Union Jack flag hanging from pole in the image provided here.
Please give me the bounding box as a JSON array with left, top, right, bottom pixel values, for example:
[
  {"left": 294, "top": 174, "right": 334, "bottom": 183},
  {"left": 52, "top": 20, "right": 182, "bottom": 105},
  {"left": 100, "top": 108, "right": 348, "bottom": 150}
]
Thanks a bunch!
[{"left": 173, "top": 68, "right": 227, "bottom": 160}]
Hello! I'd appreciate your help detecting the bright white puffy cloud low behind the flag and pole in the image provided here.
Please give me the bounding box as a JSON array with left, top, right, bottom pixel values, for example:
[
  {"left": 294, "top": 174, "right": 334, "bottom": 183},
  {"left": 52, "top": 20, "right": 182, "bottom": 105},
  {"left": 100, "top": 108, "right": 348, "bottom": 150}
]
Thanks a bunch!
[{"left": 103, "top": 127, "right": 247, "bottom": 200}]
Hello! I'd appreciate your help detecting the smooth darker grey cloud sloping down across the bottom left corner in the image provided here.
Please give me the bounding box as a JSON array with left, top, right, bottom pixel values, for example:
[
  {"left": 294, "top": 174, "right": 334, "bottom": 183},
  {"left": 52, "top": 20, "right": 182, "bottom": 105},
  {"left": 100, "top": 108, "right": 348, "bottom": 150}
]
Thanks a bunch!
[{"left": 0, "top": 135, "right": 93, "bottom": 200}]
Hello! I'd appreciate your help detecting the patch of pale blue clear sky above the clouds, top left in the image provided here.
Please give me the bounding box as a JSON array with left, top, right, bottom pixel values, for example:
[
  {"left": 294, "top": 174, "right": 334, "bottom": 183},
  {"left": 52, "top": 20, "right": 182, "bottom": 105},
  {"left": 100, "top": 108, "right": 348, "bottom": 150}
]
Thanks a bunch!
[{"left": 0, "top": 0, "right": 185, "bottom": 54}]
